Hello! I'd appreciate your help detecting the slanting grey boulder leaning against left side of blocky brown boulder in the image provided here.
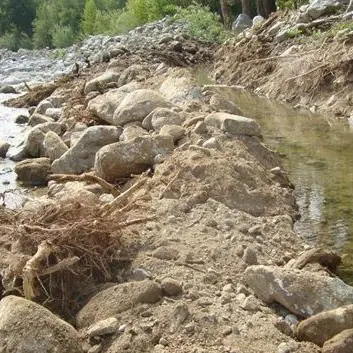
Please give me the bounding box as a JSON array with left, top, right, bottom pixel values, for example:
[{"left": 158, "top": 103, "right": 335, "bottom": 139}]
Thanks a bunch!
[{"left": 52, "top": 126, "right": 121, "bottom": 174}]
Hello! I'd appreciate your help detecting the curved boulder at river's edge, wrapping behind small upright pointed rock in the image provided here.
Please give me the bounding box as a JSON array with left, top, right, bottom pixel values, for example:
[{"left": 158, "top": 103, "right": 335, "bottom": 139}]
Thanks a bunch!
[{"left": 25, "top": 123, "right": 65, "bottom": 157}]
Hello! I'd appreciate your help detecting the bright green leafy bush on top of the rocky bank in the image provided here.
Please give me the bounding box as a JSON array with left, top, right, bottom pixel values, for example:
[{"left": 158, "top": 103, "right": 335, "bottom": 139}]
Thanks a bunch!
[{"left": 175, "top": 3, "right": 227, "bottom": 42}]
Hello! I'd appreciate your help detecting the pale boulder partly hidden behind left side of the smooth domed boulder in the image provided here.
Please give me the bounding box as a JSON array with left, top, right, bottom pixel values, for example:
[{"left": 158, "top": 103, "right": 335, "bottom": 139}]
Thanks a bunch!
[{"left": 88, "top": 82, "right": 140, "bottom": 125}]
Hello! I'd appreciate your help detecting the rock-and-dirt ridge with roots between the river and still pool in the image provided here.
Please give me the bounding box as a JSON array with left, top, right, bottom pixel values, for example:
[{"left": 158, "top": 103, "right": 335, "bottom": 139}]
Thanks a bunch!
[{"left": 0, "top": 15, "right": 353, "bottom": 353}]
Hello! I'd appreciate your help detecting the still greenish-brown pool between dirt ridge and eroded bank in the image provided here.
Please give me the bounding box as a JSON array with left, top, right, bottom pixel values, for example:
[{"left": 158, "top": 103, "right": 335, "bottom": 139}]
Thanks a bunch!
[{"left": 206, "top": 88, "right": 353, "bottom": 284}]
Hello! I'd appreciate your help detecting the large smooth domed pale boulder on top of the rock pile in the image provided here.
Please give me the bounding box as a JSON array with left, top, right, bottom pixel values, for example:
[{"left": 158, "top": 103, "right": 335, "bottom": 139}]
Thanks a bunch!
[{"left": 113, "top": 89, "right": 171, "bottom": 126}]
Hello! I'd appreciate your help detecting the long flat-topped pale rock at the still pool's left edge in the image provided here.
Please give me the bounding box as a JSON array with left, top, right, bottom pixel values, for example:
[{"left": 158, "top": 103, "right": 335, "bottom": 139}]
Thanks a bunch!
[{"left": 205, "top": 113, "right": 261, "bottom": 136}]
